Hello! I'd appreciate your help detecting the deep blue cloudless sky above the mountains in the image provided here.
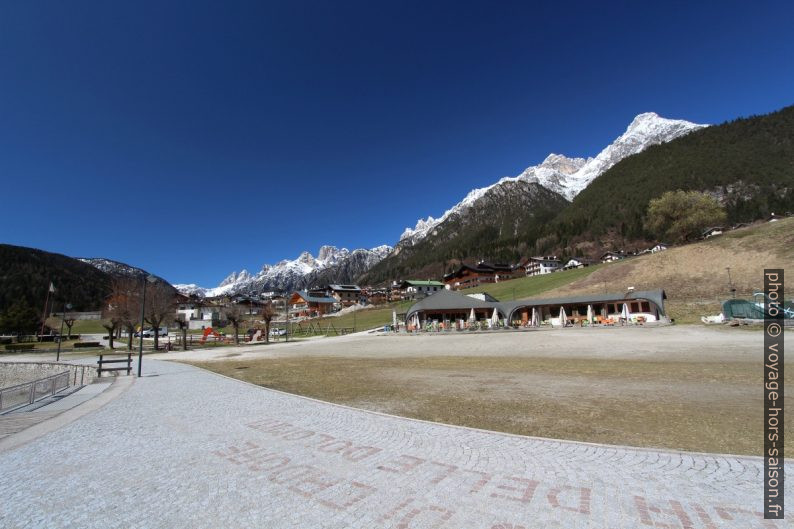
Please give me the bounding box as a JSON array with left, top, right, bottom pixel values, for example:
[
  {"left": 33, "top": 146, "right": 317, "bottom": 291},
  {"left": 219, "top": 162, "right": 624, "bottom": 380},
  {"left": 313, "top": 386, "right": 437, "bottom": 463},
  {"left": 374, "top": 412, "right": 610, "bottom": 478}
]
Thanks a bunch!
[{"left": 0, "top": 0, "right": 794, "bottom": 286}]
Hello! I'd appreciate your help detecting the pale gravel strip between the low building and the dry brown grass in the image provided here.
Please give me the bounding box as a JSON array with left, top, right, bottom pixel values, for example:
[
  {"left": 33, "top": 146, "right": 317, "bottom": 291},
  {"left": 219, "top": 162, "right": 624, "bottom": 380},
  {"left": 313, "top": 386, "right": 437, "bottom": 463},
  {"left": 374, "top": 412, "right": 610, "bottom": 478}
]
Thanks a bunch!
[{"left": 161, "top": 325, "right": 763, "bottom": 362}]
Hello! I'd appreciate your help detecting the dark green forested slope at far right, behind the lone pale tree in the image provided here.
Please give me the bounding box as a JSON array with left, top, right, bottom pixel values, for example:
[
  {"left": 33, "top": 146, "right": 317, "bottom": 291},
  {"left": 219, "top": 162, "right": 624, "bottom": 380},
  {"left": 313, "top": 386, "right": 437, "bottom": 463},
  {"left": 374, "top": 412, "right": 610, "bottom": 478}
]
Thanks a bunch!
[{"left": 541, "top": 106, "right": 794, "bottom": 251}]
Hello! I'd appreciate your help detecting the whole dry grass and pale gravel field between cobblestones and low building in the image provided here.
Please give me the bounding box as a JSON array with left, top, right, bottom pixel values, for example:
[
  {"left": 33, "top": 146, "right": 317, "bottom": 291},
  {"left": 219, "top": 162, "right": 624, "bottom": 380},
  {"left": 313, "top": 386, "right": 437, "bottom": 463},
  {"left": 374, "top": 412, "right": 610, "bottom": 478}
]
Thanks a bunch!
[{"left": 166, "top": 326, "right": 794, "bottom": 454}]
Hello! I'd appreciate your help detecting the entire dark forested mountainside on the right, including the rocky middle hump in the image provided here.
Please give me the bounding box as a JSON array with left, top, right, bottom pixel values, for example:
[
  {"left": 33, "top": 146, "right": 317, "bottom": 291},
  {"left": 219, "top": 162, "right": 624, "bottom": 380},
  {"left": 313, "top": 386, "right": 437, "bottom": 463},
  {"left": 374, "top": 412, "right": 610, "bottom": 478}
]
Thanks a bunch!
[{"left": 359, "top": 106, "right": 794, "bottom": 283}]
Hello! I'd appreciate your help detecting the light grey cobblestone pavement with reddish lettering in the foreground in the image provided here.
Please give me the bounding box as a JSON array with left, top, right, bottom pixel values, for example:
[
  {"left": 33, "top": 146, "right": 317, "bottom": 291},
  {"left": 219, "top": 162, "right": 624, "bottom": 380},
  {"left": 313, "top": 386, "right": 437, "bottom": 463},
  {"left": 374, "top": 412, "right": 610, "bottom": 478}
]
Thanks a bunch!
[{"left": 0, "top": 360, "right": 794, "bottom": 529}]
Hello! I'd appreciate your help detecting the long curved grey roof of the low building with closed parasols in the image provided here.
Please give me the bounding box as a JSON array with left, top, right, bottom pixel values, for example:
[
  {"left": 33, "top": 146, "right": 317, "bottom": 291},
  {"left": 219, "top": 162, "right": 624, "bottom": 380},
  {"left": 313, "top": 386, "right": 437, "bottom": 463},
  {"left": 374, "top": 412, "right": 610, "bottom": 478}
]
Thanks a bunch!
[{"left": 406, "top": 289, "right": 667, "bottom": 317}]
